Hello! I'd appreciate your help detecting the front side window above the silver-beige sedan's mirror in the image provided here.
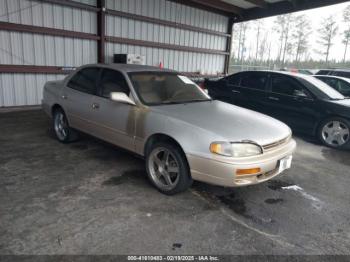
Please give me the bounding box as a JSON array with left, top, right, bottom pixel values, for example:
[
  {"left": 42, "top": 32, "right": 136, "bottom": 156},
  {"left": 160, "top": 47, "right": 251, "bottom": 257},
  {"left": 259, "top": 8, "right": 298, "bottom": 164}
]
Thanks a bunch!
[{"left": 100, "top": 69, "right": 130, "bottom": 98}]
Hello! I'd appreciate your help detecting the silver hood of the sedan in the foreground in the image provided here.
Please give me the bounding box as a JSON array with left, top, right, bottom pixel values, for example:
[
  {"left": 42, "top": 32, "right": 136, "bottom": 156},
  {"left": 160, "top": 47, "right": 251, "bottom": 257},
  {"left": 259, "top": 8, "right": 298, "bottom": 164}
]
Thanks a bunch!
[{"left": 151, "top": 101, "right": 291, "bottom": 145}]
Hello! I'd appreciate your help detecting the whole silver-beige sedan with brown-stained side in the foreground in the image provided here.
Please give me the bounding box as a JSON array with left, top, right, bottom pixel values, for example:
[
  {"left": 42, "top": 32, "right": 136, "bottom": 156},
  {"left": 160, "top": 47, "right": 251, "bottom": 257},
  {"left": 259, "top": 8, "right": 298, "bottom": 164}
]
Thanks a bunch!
[{"left": 42, "top": 64, "right": 296, "bottom": 194}]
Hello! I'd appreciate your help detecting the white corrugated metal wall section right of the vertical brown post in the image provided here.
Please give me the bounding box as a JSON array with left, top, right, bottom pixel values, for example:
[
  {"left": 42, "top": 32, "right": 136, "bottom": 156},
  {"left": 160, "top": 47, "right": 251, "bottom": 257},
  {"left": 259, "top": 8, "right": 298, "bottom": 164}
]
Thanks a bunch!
[{"left": 106, "top": 0, "right": 228, "bottom": 74}]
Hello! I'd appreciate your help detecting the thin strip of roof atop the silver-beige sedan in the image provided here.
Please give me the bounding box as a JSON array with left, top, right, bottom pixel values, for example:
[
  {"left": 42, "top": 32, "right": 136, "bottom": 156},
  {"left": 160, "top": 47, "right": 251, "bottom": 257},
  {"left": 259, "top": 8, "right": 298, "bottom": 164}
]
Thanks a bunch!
[{"left": 80, "top": 63, "right": 176, "bottom": 73}]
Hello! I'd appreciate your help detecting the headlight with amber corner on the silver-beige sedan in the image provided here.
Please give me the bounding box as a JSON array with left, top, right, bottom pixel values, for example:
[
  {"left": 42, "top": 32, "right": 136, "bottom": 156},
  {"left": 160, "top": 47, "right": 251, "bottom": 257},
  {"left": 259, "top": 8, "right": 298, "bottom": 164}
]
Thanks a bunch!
[{"left": 210, "top": 142, "right": 263, "bottom": 157}]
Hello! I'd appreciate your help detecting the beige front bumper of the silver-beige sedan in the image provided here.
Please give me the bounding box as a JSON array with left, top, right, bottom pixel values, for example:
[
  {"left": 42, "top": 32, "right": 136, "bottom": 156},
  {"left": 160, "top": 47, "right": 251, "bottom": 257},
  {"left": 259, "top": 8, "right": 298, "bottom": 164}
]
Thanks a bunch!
[{"left": 187, "top": 139, "right": 296, "bottom": 187}]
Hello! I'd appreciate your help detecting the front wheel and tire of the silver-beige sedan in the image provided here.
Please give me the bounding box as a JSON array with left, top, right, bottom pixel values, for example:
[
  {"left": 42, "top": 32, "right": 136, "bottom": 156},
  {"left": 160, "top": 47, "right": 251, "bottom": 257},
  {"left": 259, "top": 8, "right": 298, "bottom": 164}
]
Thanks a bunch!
[{"left": 146, "top": 143, "right": 192, "bottom": 195}]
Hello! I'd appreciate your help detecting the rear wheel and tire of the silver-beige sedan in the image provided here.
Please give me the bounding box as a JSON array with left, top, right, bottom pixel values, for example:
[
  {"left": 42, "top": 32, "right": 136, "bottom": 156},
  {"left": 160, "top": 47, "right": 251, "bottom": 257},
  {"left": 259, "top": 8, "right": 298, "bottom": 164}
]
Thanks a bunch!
[{"left": 53, "top": 108, "right": 78, "bottom": 143}]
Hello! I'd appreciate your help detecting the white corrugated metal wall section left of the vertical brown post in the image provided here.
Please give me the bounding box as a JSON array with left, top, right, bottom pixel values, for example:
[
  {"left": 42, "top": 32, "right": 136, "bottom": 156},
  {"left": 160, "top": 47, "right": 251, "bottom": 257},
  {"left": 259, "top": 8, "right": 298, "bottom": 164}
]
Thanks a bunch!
[{"left": 0, "top": 0, "right": 97, "bottom": 106}]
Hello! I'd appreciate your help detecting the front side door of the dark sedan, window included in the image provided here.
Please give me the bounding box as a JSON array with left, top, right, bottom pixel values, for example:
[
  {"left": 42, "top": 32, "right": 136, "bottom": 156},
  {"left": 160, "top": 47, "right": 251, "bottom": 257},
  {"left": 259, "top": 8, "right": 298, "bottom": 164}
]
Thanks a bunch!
[{"left": 265, "top": 74, "right": 318, "bottom": 132}]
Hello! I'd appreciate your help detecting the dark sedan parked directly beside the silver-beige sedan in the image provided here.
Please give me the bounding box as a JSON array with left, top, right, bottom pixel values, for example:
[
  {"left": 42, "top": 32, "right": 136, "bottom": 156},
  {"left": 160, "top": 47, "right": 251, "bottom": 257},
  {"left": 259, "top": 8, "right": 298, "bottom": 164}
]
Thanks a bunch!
[{"left": 204, "top": 71, "right": 350, "bottom": 148}]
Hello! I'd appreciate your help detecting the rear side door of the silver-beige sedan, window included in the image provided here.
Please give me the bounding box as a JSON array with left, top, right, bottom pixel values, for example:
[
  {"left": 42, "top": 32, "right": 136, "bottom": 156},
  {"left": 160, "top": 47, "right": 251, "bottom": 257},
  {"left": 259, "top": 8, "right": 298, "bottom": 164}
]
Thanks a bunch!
[{"left": 62, "top": 67, "right": 100, "bottom": 133}]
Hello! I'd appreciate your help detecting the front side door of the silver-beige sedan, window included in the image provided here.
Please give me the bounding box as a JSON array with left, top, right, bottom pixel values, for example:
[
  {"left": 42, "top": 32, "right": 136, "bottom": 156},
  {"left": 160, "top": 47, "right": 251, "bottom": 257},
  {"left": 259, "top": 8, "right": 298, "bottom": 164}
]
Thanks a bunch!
[{"left": 92, "top": 69, "right": 137, "bottom": 151}]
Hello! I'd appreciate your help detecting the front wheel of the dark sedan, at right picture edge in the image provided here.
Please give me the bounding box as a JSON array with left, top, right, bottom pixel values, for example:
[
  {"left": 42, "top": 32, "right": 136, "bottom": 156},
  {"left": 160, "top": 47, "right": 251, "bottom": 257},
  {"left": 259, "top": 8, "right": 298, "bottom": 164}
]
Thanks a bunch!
[{"left": 318, "top": 117, "right": 350, "bottom": 149}]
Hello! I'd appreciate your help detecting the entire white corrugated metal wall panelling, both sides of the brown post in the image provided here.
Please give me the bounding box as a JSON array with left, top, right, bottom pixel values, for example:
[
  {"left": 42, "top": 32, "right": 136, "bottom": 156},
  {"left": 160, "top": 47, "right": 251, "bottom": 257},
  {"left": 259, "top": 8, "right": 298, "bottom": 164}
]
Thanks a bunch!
[{"left": 0, "top": 0, "right": 228, "bottom": 107}]
